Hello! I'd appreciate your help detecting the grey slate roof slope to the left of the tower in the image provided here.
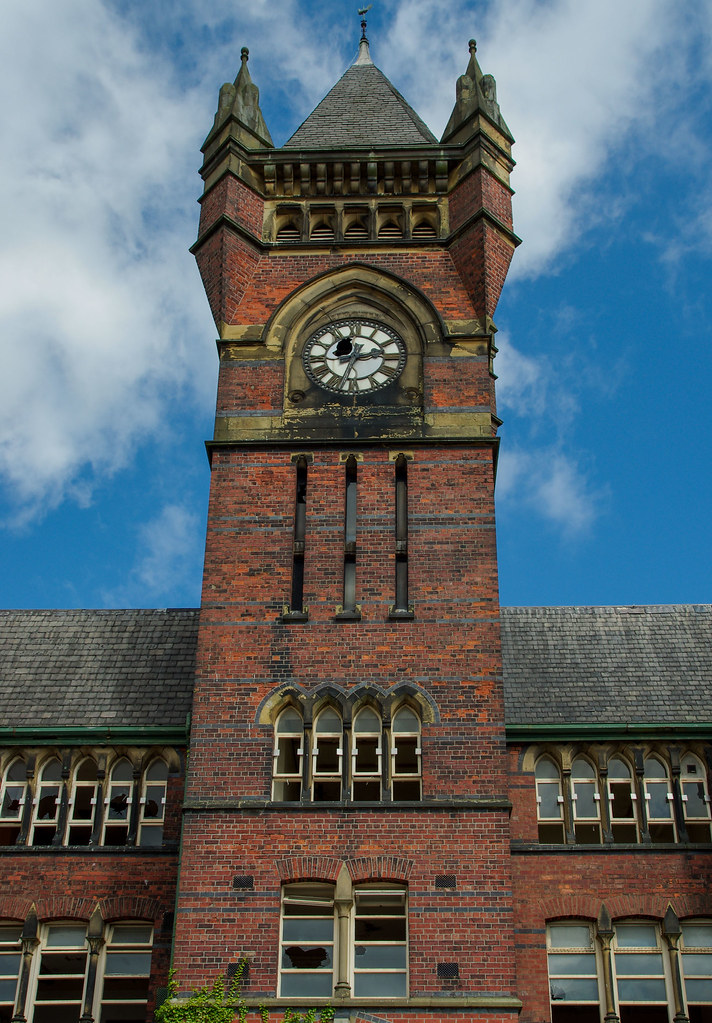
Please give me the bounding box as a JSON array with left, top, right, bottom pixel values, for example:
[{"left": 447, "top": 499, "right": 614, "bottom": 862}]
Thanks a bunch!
[{"left": 0, "top": 609, "right": 198, "bottom": 728}]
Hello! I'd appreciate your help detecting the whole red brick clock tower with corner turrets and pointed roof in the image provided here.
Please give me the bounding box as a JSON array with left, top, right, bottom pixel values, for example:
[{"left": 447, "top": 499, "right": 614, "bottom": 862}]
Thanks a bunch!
[{"left": 175, "top": 26, "right": 520, "bottom": 1023}]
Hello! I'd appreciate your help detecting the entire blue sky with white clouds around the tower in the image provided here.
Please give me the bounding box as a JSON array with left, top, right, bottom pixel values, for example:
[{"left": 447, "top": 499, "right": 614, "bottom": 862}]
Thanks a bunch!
[{"left": 0, "top": 0, "right": 712, "bottom": 608}]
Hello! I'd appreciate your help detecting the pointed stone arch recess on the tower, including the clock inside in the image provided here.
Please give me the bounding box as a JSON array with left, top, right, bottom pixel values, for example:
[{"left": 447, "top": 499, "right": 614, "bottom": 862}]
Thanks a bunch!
[{"left": 265, "top": 263, "right": 443, "bottom": 438}]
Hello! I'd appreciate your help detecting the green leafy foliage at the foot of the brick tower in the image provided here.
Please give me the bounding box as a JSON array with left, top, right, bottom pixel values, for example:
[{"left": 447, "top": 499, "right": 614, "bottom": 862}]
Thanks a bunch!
[{"left": 154, "top": 960, "right": 335, "bottom": 1023}]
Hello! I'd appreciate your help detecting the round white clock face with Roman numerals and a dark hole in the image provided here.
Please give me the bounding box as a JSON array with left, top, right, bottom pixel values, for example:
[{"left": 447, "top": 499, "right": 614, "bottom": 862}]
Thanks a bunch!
[{"left": 302, "top": 317, "right": 406, "bottom": 394}]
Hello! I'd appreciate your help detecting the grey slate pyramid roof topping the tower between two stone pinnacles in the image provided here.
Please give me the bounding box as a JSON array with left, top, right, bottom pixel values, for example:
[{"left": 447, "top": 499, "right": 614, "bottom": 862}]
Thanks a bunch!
[{"left": 284, "top": 39, "right": 437, "bottom": 149}]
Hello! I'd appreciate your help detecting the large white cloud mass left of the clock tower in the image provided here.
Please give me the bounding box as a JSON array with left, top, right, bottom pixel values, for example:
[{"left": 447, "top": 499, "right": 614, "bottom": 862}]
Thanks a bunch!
[{"left": 0, "top": 0, "right": 214, "bottom": 518}]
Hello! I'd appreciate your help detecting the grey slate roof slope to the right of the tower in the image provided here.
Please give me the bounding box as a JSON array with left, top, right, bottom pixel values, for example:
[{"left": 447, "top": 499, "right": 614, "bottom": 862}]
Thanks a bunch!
[{"left": 501, "top": 605, "right": 712, "bottom": 725}]
